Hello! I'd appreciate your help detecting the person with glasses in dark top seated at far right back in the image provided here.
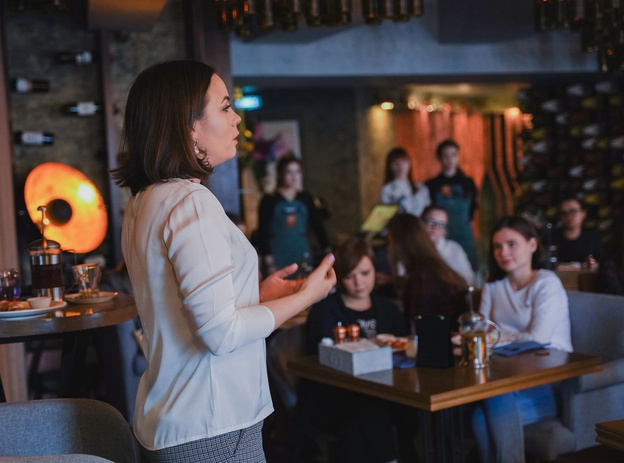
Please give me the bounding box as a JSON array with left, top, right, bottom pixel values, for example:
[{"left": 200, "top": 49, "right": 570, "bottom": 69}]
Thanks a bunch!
[{"left": 552, "top": 197, "right": 605, "bottom": 263}]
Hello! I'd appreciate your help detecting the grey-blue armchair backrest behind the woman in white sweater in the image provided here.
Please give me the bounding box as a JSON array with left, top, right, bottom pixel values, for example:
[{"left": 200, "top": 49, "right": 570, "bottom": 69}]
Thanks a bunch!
[{"left": 568, "top": 291, "right": 624, "bottom": 362}]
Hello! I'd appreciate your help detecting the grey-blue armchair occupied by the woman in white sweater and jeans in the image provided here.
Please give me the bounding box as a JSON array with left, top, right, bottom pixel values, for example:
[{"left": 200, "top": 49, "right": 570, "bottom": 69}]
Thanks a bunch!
[{"left": 524, "top": 291, "right": 624, "bottom": 461}]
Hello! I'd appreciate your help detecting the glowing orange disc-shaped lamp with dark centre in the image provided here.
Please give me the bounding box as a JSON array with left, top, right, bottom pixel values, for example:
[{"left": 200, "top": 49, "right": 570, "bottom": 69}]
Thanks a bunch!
[{"left": 24, "top": 162, "right": 108, "bottom": 253}]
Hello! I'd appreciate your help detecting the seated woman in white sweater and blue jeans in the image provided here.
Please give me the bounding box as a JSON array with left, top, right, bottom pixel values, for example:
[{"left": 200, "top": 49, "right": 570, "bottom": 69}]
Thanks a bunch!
[{"left": 473, "top": 216, "right": 572, "bottom": 463}]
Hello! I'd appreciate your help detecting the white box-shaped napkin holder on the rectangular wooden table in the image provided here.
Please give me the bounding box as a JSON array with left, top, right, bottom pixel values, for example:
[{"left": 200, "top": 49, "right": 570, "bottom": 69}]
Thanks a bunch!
[{"left": 319, "top": 339, "right": 392, "bottom": 375}]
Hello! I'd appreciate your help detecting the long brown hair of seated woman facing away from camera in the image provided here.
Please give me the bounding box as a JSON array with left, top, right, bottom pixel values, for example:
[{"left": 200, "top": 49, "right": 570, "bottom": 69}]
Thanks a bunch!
[{"left": 388, "top": 214, "right": 466, "bottom": 290}]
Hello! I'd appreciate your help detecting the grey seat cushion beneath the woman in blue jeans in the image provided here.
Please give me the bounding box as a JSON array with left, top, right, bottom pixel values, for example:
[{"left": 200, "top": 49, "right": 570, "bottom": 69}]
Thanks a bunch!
[{"left": 524, "top": 419, "right": 576, "bottom": 461}]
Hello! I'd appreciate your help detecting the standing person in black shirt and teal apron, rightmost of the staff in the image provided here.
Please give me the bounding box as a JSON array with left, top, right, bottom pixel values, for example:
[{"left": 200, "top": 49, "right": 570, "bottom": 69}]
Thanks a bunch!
[{"left": 426, "top": 139, "right": 479, "bottom": 270}]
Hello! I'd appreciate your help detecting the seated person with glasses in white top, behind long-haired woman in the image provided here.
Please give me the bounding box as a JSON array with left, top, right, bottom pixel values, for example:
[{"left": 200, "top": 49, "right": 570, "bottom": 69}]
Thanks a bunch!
[{"left": 421, "top": 206, "right": 475, "bottom": 285}]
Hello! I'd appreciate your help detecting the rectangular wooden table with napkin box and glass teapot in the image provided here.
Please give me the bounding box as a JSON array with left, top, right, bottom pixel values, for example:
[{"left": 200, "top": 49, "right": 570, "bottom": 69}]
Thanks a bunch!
[{"left": 288, "top": 350, "right": 602, "bottom": 462}]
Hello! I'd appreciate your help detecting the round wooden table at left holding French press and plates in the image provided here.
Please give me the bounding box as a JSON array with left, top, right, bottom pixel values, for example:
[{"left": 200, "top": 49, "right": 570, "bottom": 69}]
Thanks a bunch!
[{"left": 0, "top": 294, "right": 138, "bottom": 408}]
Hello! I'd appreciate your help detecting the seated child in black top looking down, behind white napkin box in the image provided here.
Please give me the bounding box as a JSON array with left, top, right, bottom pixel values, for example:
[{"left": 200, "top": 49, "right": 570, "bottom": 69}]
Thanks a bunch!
[{"left": 298, "top": 238, "right": 407, "bottom": 463}]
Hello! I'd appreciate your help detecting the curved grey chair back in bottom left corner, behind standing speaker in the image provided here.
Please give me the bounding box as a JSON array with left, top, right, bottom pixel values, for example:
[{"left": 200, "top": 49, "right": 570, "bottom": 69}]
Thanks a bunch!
[{"left": 0, "top": 399, "right": 138, "bottom": 463}]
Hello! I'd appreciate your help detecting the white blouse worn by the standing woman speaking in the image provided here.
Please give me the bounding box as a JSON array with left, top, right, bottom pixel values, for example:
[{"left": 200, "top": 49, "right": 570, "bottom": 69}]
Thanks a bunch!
[{"left": 122, "top": 180, "right": 275, "bottom": 450}]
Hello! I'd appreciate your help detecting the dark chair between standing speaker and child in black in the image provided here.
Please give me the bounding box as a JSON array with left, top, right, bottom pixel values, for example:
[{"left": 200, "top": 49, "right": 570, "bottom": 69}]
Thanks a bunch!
[{"left": 266, "top": 325, "right": 338, "bottom": 463}]
